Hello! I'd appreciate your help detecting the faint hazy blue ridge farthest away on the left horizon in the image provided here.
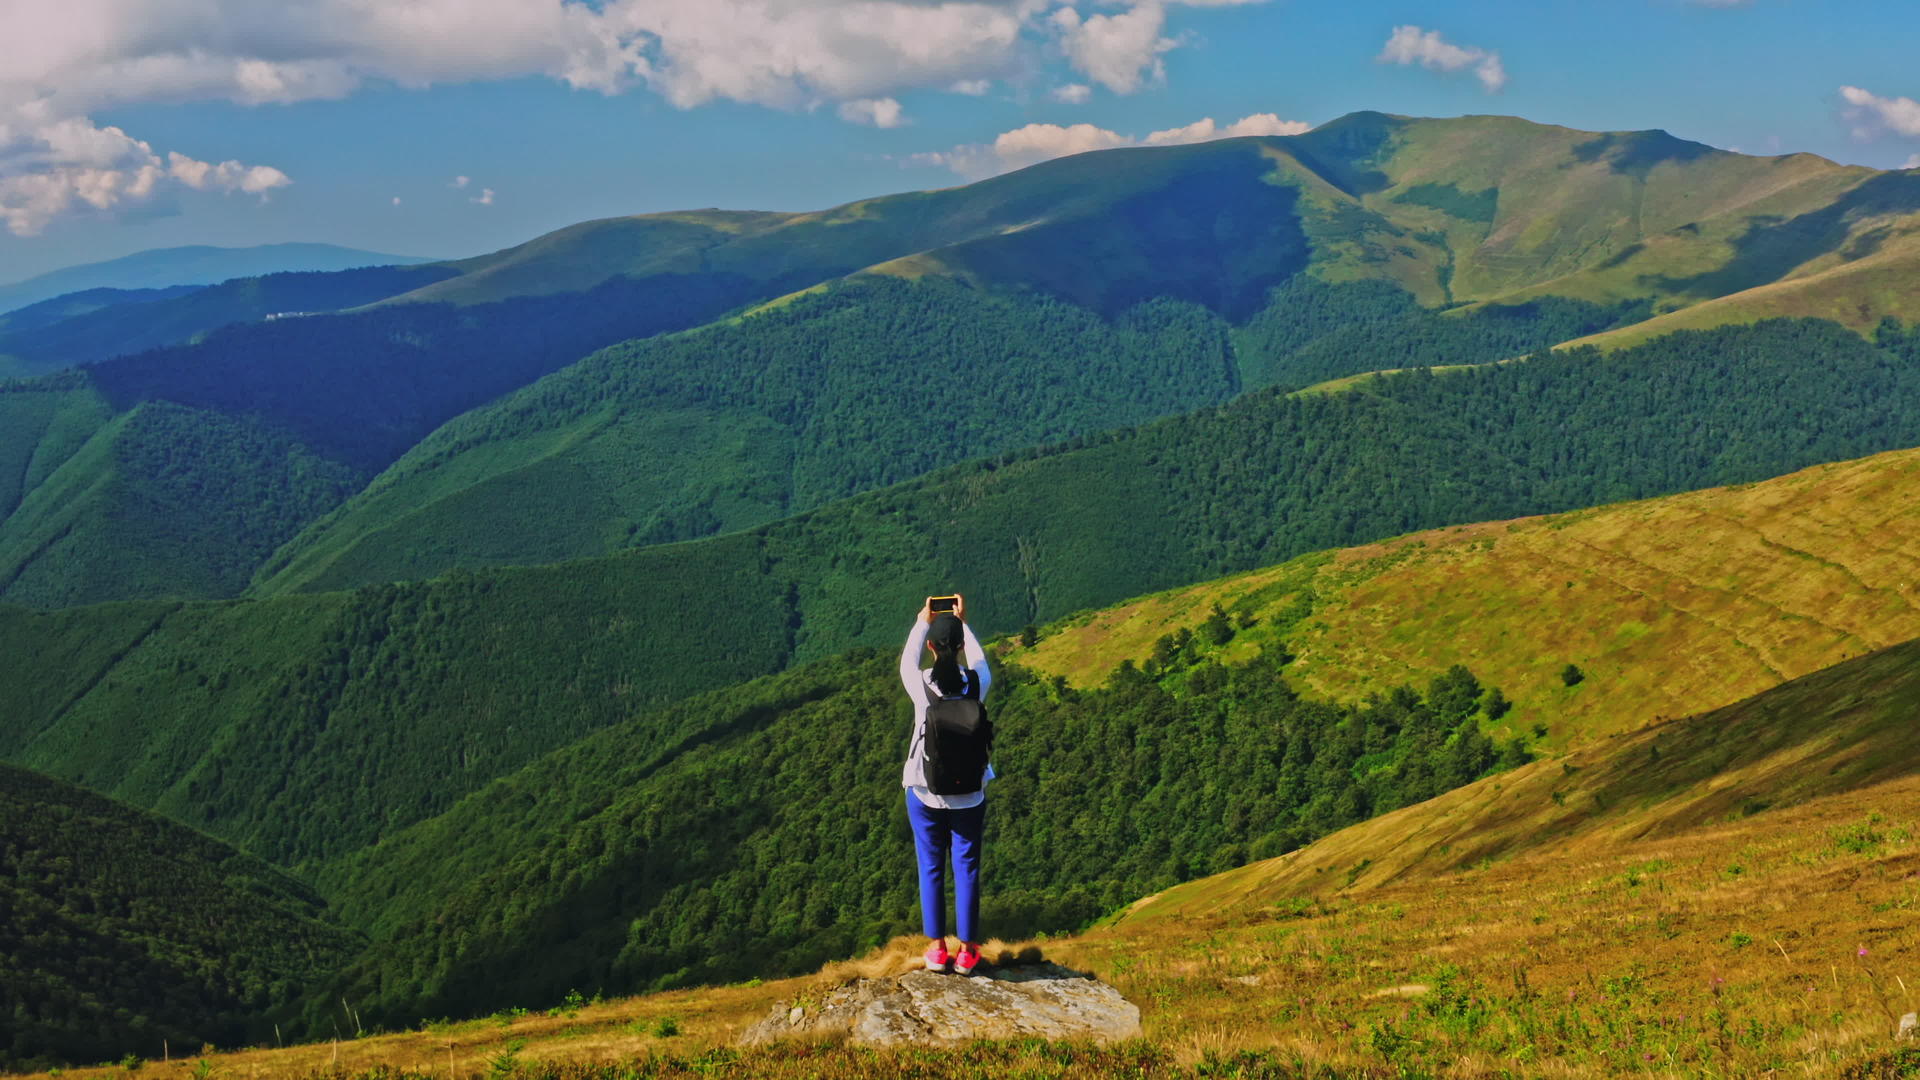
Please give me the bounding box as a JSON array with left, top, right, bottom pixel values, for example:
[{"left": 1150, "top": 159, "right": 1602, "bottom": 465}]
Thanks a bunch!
[{"left": 0, "top": 242, "right": 438, "bottom": 313}]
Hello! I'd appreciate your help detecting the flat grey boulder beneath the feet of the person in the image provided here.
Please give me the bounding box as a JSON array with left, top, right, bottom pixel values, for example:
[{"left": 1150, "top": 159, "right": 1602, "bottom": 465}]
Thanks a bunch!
[{"left": 741, "top": 963, "right": 1140, "bottom": 1045}]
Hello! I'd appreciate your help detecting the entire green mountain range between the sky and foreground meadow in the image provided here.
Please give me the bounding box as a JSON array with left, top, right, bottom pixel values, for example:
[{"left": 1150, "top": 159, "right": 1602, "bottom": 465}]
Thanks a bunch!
[{"left": 11, "top": 113, "right": 1920, "bottom": 1063}]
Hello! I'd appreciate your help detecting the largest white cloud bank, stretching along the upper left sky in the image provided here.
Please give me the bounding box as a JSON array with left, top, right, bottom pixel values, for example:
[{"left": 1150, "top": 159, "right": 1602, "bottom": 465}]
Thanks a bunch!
[{"left": 0, "top": 0, "right": 1260, "bottom": 231}]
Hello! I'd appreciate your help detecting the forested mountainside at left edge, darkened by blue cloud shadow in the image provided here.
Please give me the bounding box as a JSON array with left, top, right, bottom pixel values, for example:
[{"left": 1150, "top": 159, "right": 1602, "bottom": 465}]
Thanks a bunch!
[{"left": 0, "top": 271, "right": 787, "bottom": 605}]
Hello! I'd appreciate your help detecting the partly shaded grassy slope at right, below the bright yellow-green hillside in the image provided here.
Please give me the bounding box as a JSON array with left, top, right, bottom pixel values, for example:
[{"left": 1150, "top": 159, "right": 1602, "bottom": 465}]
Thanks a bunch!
[{"left": 1127, "top": 644, "right": 1920, "bottom": 920}]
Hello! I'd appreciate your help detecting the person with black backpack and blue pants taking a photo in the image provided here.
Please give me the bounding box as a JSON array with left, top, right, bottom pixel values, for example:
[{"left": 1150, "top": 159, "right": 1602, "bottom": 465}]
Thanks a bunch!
[{"left": 900, "top": 594, "right": 993, "bottom": 974}]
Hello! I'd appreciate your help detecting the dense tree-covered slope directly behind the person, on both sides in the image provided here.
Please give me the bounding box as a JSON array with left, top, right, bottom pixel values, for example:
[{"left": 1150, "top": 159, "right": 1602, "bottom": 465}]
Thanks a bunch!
[{"left": 309, "top": 613, "right": 1528, "bottom": 1030}]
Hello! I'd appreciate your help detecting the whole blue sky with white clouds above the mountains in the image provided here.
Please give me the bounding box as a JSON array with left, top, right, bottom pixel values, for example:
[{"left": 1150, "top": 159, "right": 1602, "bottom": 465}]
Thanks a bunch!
[{"left": 0, "top": 0, "right": 1920, "bottom": 281}]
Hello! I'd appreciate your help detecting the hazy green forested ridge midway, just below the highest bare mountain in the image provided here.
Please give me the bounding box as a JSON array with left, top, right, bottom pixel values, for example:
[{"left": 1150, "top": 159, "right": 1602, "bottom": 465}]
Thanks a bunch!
[{"left": 257, "top": 275, "right": 1644, "bottom": 596}]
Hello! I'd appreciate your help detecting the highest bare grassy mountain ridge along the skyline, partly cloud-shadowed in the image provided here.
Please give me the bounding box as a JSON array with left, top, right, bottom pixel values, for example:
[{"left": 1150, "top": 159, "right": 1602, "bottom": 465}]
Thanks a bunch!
[{"left": 399, "top": 113, "right": 1920, "bottom": 326}]
